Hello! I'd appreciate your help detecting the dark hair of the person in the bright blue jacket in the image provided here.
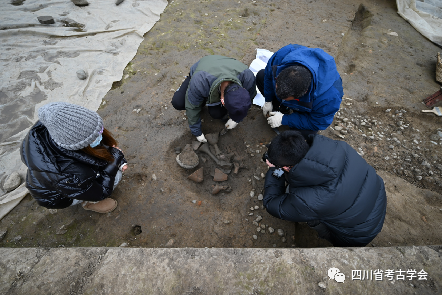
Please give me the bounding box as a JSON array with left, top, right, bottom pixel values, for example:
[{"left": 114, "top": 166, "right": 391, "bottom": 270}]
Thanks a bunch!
[{"left": 276, "top": 65, "right": 313, "bottom": 99}]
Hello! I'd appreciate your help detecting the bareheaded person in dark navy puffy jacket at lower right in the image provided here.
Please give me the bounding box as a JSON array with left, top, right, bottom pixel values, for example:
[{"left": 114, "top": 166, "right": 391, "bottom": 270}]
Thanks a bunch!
[{"left": 263, "top": 130, "right": 387, "bottom": 247}]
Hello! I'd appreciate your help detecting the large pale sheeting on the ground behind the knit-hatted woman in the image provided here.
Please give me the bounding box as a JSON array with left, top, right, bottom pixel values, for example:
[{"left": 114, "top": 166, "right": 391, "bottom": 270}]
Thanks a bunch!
[{"left": 0, "top": 0, "right": 167, "bottom": 219}]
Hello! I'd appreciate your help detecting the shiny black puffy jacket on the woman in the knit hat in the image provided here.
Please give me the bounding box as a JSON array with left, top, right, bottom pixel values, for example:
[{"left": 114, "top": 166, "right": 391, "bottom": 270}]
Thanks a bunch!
[{"left": 20, "top": 121, "right": 125, "bottom": 209}]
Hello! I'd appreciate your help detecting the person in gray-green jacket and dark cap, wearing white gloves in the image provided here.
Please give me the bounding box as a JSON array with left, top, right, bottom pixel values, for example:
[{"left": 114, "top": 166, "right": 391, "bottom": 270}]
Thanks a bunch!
[{"left": 172, "top": 55, "right": 256, "bottom": 142}]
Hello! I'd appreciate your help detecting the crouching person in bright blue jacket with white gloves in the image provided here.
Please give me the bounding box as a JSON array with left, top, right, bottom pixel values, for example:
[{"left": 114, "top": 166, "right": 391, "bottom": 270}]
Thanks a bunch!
[{"left": 256, "top": 44, "right": 344, "bottom": 138}]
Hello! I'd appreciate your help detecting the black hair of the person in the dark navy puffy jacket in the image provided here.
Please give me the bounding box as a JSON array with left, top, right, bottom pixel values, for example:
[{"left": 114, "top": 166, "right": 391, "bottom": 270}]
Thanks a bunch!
[{"left": 267, "top": 130, "right": 310, "bottom": 167}]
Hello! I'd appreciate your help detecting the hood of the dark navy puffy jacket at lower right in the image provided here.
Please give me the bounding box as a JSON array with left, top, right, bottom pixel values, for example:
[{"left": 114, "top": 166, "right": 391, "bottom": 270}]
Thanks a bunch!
[{"left": 287, "top": 135, "right": 345, "bottom": 187}]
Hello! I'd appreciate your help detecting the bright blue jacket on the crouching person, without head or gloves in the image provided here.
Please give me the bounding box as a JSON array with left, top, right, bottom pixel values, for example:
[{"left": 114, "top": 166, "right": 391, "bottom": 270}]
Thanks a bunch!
[{"left": 264, "top": 44, "right": 344, "bottom": 130}]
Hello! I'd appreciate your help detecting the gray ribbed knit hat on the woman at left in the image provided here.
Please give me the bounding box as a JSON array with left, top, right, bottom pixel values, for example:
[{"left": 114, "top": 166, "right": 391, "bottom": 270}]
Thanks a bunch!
[{"left": 38, "top": 102, "right": 103, "bottom": 150}]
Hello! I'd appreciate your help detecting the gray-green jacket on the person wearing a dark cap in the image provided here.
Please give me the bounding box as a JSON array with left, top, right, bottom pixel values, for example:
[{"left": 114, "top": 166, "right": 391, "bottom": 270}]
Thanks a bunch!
[{"left": 186, "top": 55, "right": 256, "bottom": 136}]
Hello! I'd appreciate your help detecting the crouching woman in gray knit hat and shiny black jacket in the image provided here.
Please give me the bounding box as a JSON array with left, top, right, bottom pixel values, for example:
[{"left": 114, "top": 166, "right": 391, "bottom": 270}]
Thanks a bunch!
[{"left": 20, "top": 102, "right": 127, "bottom": 213}]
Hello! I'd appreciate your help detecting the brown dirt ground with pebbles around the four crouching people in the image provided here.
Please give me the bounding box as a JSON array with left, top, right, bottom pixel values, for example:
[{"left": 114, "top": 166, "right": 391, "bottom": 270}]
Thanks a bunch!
[{"left": 0, "top": 0, "right": 442, "bottom": 248}]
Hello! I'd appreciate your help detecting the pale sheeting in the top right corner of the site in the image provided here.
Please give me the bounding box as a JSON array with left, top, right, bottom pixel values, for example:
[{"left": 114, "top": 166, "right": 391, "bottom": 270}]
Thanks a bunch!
[{"left": 396, "top": 0, "right": 442, "bottom": 46}]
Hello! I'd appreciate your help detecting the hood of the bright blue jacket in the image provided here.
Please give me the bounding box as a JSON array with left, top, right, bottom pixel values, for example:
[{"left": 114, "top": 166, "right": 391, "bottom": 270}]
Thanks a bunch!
[{"left": 275, "top": 45, "right": 337, "bottom": 102}]
